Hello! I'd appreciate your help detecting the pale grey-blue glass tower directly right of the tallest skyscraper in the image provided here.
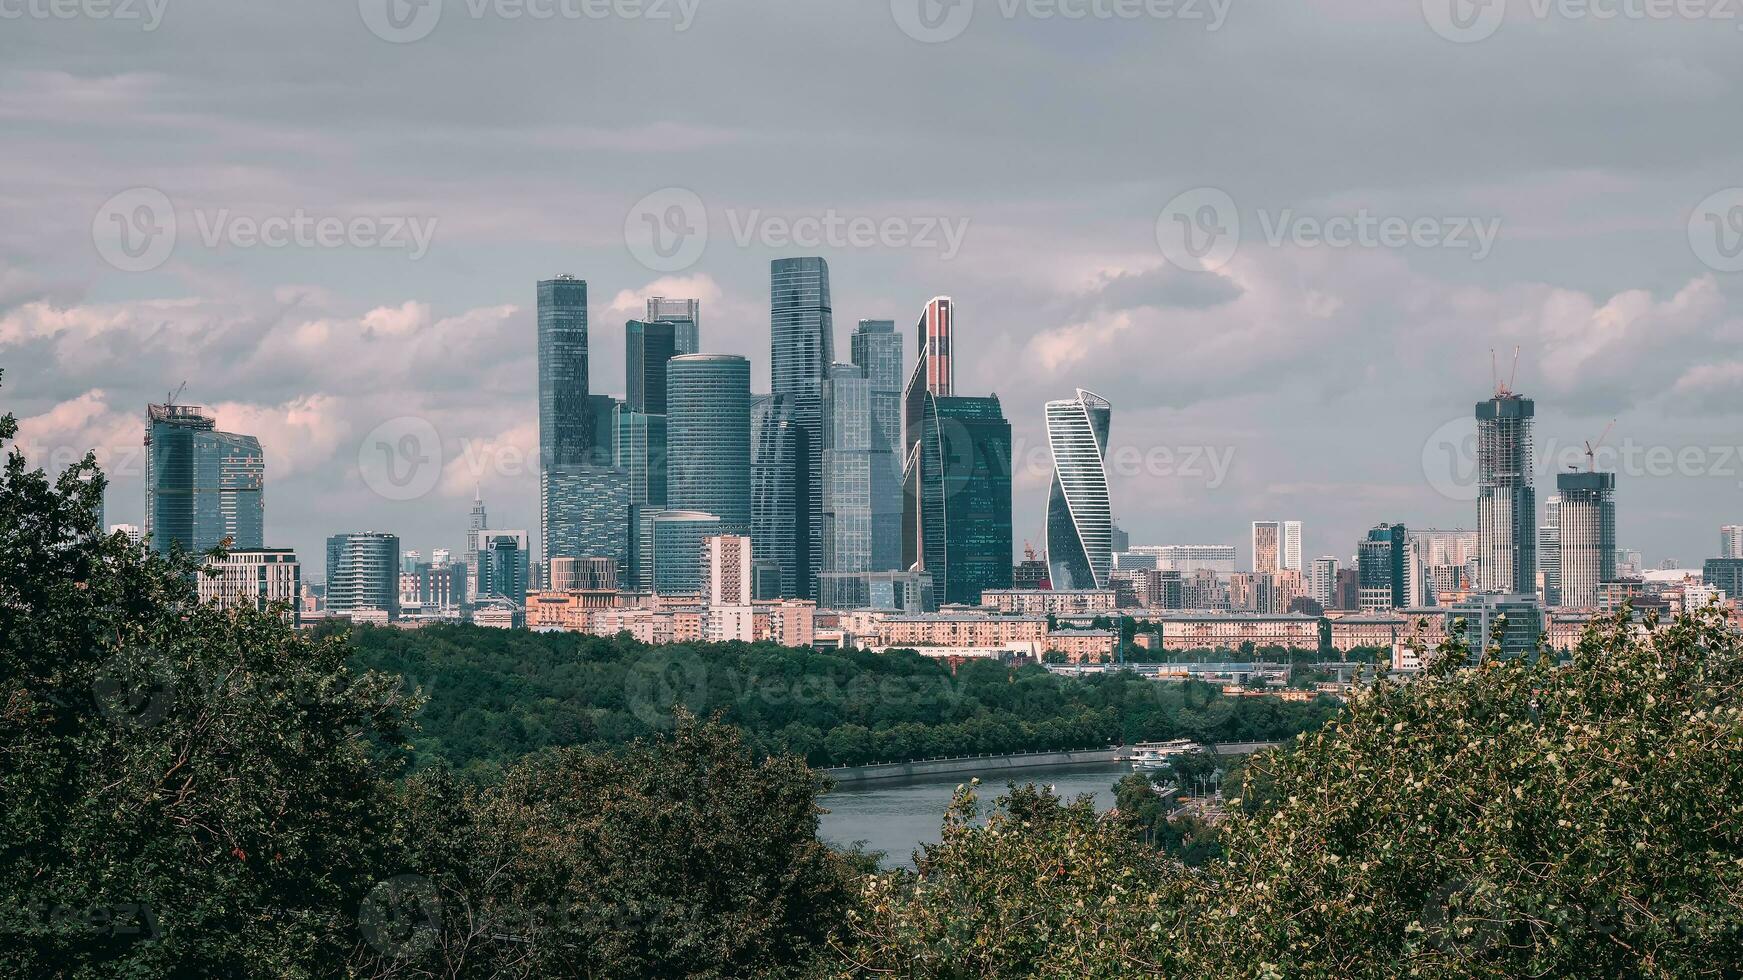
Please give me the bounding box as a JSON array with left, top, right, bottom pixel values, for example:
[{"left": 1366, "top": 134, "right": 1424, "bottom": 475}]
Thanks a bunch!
[{"left": 823, "top": 364, "right": 871, "bottom": 574}]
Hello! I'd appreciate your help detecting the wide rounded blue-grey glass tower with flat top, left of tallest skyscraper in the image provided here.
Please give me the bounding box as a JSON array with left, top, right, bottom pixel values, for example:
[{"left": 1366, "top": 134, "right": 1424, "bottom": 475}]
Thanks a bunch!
[{"left": 666, "top": 354, "right": 751, "bottom": 534}]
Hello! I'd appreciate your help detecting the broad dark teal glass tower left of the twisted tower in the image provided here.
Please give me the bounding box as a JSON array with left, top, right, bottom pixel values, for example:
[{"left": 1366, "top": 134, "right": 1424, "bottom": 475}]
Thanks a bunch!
[{"left": 903, "top": 392, "right": 1011, "bottom": 605}]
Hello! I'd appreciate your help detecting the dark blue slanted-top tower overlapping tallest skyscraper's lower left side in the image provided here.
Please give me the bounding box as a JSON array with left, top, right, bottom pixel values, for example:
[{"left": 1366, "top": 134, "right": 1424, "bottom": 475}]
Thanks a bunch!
[{"left": 751, "top": 394, "right": 810, "bottom": 598}]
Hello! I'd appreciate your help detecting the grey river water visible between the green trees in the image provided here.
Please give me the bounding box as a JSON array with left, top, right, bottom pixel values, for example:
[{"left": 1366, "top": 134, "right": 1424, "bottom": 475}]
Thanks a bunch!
[{"left": 819, "top": 762, "right": 1131, "bottom": 868}]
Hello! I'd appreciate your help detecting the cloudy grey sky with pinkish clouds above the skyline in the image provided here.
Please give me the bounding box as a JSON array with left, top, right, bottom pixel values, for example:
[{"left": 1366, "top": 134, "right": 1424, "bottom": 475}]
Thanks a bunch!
[{"left": 0, "top": 0, "right": 1743, "bottom": 579}]
